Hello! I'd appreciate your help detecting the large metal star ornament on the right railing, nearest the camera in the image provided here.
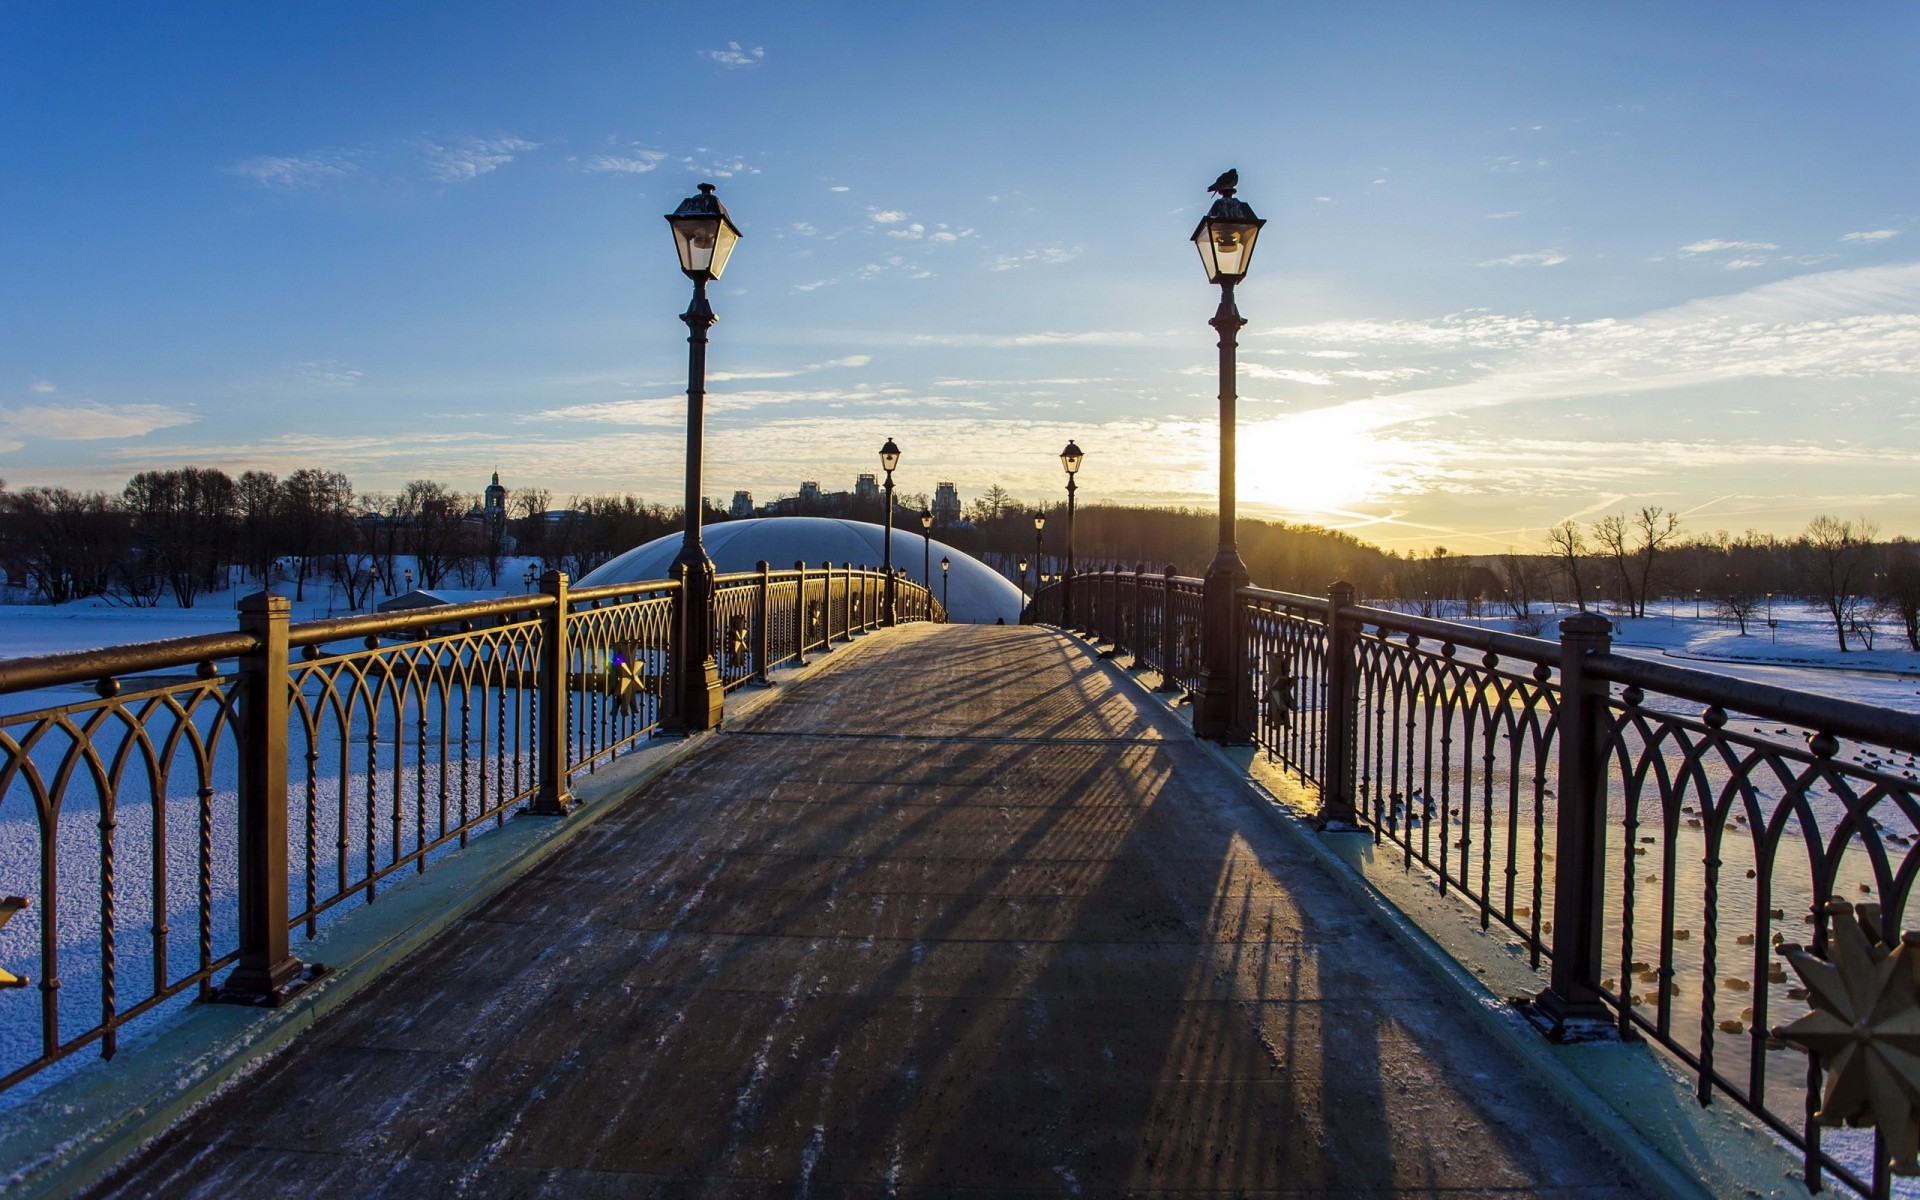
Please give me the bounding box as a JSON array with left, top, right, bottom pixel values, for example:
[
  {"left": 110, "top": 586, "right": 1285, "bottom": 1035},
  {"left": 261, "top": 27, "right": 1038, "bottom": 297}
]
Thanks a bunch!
[{"left": 1774, "top": 900, "right": 1920, "bottom": 1175}]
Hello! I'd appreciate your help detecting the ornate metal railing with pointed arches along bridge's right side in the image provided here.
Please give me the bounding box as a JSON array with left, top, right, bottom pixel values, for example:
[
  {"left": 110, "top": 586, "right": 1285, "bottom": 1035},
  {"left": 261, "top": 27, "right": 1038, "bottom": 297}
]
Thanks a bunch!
[{"left": 1029, "top": 572, "right": 1920, "bottom": 1194}]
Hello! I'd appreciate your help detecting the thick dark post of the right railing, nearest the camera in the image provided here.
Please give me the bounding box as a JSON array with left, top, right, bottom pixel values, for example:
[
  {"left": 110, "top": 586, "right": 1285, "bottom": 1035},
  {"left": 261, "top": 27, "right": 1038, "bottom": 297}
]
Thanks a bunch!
[{"left": 1534, "top": 612, "right": 1613, "bottom": 1041}]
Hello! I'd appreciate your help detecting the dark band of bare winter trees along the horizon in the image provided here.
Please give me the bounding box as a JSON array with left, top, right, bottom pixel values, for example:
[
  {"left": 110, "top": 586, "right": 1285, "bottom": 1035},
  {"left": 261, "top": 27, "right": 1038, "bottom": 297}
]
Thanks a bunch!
[{"left": 0, "top": 467, "right": 1920, "bottom": 651}]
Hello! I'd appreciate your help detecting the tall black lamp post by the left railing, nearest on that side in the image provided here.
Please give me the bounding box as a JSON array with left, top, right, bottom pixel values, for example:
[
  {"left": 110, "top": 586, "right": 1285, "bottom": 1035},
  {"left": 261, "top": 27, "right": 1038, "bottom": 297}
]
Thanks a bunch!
[{"left": 666, "top": 182, "right": 739, "bottom": 733}]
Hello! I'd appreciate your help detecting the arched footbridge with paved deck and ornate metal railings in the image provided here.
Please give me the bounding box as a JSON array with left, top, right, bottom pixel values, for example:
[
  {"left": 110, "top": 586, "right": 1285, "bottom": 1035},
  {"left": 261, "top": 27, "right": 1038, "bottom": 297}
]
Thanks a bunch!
[{"left": 0, "top": 566, "right": 1920, "bottom": 1196}]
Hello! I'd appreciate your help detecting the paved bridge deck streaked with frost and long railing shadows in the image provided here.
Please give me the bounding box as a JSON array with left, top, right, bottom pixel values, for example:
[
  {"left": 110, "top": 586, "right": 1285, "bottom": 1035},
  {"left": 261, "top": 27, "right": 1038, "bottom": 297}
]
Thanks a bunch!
[{"left": 90, "top": 626, "right": 1630, "bottom": 1200}]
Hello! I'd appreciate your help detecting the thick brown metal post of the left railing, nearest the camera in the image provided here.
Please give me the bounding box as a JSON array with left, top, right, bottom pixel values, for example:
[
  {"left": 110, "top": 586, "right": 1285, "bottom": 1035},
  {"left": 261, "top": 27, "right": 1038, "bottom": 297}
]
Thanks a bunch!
[{"left": 213, "top": 591, "right": 309, "bottom": 1008}]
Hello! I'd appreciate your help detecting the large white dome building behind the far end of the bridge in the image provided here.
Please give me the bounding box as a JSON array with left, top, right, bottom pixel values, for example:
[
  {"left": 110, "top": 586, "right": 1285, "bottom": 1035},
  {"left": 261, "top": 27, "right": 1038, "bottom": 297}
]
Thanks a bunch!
[{"left": 574, "top": 516, "right": 1025, "bottom": 624}]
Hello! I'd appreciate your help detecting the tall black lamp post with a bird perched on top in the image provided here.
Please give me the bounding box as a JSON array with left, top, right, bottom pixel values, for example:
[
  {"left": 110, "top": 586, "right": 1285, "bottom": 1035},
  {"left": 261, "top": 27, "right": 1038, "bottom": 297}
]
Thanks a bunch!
[{"left": 1192, "top": 171, "right": 1265, "bottom": 741}]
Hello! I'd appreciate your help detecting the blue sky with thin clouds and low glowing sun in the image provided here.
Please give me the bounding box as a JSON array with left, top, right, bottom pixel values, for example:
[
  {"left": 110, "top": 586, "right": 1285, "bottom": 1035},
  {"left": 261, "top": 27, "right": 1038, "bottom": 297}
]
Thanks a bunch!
[{"left": 0, "top": 0, "right": 1920, "bottom": 553}]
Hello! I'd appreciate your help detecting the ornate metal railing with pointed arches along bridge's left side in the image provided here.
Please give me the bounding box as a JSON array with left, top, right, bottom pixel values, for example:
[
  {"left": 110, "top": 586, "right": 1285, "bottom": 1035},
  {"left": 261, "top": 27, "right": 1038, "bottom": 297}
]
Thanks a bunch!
[{"left": 0, "top": 564, "right": 945, "bottom": 1091}]
